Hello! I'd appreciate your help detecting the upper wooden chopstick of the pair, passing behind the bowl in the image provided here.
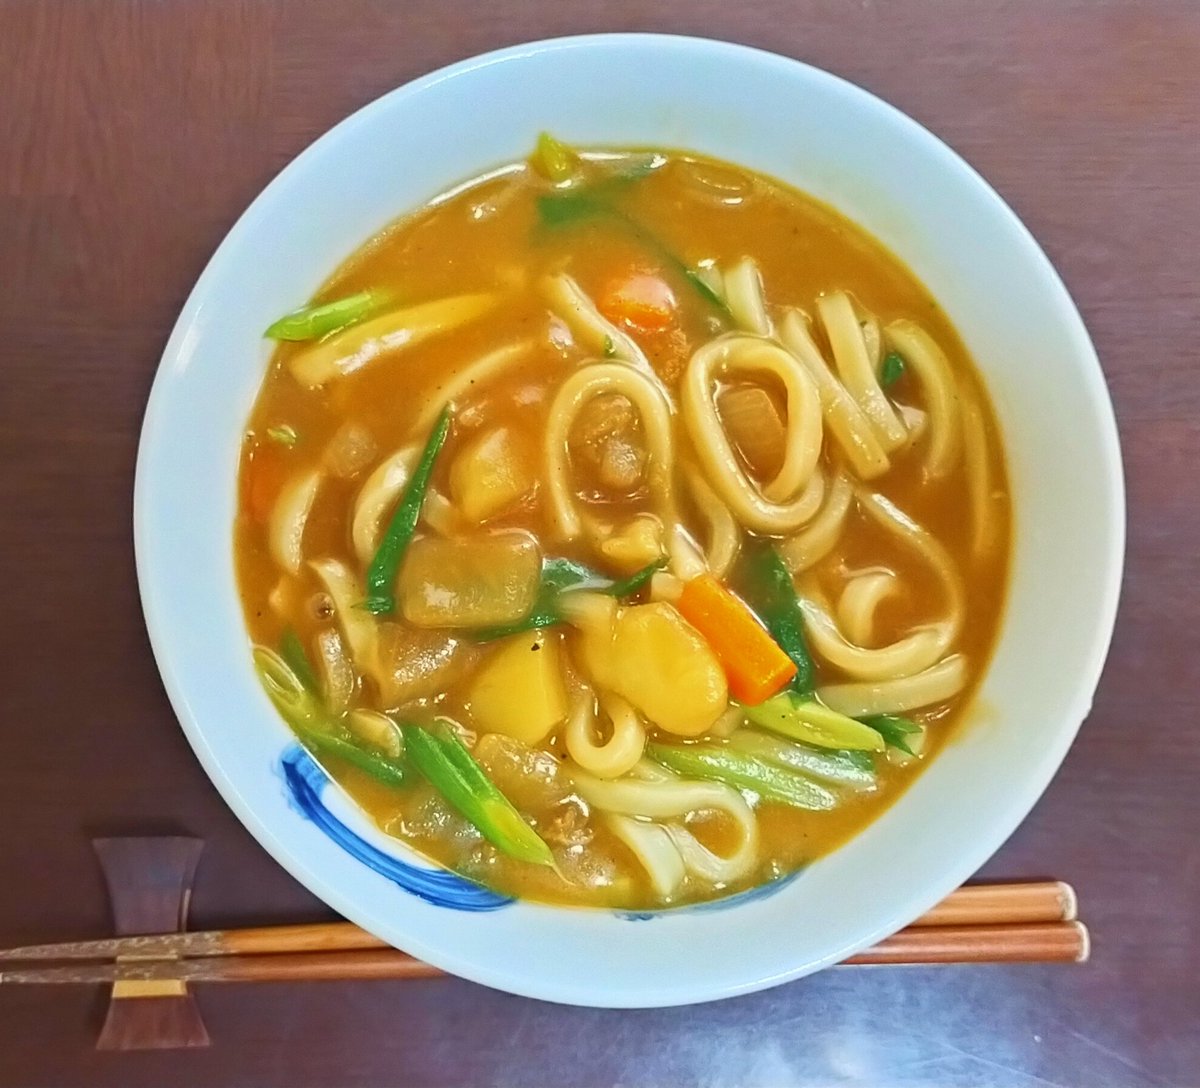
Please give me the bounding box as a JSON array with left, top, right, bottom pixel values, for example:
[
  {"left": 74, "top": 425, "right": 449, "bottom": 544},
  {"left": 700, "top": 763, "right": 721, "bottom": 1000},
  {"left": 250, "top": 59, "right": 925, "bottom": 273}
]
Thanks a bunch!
[{"left": 0, "top": 880, "right": 1076, "bottom": 961}]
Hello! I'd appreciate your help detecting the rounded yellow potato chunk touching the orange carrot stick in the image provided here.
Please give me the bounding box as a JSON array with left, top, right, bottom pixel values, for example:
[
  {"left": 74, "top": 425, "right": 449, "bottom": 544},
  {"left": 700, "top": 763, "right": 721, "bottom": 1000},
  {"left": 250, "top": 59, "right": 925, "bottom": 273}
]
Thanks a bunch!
[{"left": 582, "top": 602, "right": 728, "bottom": 737}]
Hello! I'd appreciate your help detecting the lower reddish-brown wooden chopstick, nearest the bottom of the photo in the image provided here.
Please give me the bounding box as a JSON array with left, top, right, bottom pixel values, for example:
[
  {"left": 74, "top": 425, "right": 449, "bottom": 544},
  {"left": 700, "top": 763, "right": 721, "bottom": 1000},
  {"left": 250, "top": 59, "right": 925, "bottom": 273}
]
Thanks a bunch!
[{"left": 0, "top": 921, "right": 1090, "bottom": 984}]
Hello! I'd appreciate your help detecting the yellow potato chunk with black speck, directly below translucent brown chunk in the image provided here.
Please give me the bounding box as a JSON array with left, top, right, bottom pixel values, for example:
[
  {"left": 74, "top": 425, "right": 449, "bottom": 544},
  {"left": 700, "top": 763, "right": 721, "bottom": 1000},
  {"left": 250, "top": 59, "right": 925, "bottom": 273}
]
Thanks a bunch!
[{"left": 468, "top": 631, "right": 566, "bottom": 745}]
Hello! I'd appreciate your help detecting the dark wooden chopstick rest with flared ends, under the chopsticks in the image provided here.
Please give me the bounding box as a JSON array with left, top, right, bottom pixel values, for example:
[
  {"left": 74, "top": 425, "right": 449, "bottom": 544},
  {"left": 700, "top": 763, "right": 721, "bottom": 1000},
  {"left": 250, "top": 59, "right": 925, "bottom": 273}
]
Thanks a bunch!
[{"left": 92, "top": 836, "right": 209, "bottom": 1051}]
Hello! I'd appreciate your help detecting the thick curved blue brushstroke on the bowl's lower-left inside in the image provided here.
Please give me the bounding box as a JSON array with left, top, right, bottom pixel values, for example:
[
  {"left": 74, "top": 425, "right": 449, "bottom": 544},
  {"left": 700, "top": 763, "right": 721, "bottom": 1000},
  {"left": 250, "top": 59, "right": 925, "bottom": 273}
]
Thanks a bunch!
[{"left": 280, "top": 744, "right": 514, "bottom": 912}]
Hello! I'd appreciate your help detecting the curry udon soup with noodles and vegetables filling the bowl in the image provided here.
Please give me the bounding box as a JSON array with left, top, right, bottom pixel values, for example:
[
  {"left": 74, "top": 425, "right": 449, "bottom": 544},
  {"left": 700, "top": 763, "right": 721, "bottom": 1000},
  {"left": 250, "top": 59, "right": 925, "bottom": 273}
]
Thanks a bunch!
[{"left": 235, "top": 137, "right": 1009, "bottom": 908}]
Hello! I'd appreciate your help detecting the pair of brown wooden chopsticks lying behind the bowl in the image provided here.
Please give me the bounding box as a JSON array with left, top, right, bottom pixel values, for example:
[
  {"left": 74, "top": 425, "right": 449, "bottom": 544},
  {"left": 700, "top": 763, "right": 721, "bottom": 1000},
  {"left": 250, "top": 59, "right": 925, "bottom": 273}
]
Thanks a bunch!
[{"left": 0, "top": 880, "right": 1088, "bottom": 984}]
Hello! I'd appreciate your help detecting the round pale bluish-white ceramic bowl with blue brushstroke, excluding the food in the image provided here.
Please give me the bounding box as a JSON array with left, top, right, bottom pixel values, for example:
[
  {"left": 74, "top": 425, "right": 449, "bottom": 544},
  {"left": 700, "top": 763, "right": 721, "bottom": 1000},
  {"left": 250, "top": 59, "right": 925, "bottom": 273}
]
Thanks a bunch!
[{"left": 134, "top": 35, "right": 1124, "bottom": 1006}]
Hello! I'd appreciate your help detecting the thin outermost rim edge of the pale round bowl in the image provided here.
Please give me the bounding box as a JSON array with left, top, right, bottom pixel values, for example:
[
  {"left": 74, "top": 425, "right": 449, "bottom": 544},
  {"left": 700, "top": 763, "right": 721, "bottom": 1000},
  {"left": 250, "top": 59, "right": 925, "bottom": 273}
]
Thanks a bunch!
[{"left": 133, "top": 34, "right": 1126, "bottom": 1008}]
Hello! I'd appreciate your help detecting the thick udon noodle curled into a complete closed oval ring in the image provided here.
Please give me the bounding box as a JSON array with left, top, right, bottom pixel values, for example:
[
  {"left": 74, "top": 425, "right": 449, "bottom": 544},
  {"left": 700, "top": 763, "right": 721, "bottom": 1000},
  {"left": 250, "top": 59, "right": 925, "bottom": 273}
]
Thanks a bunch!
[{"left": 680, "top": 333, "right": 824, "bottom": 534}]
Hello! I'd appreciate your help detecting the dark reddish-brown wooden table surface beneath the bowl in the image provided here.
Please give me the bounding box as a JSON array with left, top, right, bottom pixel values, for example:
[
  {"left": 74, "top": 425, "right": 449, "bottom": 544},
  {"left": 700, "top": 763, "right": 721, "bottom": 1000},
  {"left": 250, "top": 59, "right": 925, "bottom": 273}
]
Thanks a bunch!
[{"left": 0, "top": 0, "right": 1200, "bottom": 1088}]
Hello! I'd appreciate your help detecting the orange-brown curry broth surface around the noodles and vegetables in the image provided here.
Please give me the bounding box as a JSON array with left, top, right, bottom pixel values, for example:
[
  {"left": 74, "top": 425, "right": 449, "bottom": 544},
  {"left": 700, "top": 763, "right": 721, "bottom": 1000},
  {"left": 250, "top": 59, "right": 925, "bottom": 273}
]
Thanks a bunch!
[{"left": 234, "top": 154, "right": 1009, "bottom": 908}]
